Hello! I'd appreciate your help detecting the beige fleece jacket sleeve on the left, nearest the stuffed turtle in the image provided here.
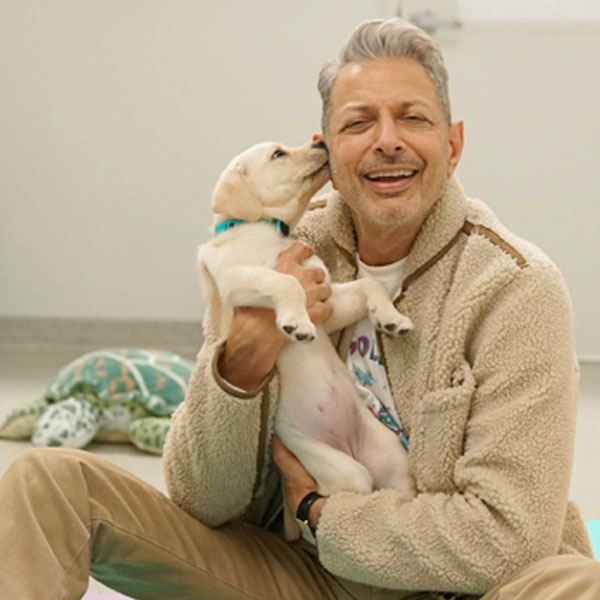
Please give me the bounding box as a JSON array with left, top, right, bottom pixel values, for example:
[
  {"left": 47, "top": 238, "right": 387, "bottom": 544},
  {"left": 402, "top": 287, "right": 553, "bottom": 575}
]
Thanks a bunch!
[{"left": 163, "top": 311, "right": 277, "bottom": 527}]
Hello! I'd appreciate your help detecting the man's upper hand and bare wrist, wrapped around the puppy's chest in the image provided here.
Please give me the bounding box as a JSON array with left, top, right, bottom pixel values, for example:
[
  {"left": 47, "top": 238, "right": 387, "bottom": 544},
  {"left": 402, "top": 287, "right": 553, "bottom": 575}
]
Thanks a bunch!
[{"left": 218, "top": 242, "right": 333, "bottom": 391}]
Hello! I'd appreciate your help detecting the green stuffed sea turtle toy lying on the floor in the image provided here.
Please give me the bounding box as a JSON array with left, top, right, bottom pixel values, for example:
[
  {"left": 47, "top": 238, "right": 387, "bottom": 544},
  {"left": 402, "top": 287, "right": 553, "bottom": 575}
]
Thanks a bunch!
[{"left": 0, "top": 349, "right": 193, "bottom": 454}]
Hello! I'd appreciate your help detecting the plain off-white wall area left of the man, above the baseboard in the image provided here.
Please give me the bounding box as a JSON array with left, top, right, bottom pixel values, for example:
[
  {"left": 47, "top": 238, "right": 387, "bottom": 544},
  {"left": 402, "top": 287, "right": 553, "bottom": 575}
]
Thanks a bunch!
[{"left": 0, "top": 0, "right": 380, "bottom": 319}]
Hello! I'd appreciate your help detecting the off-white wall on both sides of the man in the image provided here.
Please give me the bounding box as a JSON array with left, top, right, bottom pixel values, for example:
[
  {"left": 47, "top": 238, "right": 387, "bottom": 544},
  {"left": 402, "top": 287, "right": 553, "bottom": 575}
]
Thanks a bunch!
[{"left": 0, "top": 0, "right": 600, "bottom": 355}]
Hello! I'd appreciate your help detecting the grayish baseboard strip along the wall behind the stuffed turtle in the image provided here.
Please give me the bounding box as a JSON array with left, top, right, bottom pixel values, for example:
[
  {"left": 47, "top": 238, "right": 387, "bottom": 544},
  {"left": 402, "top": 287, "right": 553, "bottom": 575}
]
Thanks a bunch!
[{"left": 0, "top": 317, "right": 202, "bottom": 357}]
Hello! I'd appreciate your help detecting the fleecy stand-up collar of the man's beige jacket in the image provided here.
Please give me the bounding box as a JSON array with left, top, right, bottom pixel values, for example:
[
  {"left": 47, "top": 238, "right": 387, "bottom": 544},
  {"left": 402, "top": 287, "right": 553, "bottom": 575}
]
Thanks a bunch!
[{"left": 325, "top": 175, "right": 467, "bottom": 290}]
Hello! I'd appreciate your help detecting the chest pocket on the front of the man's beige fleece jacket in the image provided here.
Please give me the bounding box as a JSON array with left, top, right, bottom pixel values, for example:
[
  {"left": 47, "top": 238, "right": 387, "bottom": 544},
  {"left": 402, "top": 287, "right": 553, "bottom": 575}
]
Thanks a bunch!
[{"left": 410, "top": 362, "right": 475, "bottom": 493}]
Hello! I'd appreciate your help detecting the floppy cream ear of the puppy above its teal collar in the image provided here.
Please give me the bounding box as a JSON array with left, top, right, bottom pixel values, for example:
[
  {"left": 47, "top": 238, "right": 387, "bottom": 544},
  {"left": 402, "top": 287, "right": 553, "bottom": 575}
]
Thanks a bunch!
[{"left": 212, "top": 163, "right": 262, "bottom": 221}]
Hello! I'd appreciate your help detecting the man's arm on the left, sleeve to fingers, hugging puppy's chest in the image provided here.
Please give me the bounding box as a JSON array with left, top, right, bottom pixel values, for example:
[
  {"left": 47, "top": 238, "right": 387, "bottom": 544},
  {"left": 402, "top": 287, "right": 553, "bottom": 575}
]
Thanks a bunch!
[{"left": 163, "top": 243, "right": 332, "bottom": 526}]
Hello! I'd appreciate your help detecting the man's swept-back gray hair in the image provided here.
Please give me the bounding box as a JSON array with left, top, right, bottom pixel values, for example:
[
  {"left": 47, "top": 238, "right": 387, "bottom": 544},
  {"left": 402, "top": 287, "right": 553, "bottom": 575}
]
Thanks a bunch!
[{"left": 318, "top": 18, "right": 451, "bottom": 132}]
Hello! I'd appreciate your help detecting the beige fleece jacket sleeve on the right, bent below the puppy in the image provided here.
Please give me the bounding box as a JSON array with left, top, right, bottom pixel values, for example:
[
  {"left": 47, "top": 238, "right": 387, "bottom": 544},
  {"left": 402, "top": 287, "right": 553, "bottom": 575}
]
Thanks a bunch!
[{"left": 317, "top": 265, "right": 578, "bottom": 594}]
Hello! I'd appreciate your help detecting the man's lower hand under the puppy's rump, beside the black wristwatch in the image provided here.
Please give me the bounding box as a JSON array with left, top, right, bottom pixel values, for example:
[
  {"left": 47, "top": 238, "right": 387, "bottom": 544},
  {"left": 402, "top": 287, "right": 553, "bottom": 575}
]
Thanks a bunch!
[{"left": 271, "top": 435, "right": 327, "bottom": 527}]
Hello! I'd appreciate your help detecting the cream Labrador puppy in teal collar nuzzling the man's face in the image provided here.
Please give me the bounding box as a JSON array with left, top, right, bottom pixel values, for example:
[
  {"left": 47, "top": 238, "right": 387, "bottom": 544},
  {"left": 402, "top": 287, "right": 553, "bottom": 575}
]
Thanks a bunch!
[{"left": 199, "top": 142, "right": 415, "bottom": 539}]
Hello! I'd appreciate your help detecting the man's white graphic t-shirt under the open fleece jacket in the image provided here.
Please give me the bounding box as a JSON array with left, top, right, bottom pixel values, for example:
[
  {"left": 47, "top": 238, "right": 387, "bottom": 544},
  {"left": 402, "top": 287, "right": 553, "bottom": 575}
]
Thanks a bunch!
[{"left": 347, "top": 256, "right": 408, "bottom": 447}]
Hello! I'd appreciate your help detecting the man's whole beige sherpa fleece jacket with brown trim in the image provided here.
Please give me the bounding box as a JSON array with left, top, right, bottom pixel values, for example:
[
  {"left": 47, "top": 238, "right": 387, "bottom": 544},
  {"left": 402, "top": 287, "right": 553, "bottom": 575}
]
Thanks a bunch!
[{"left": 164, "top": 178, "right": 591, "bottom": 594}]
